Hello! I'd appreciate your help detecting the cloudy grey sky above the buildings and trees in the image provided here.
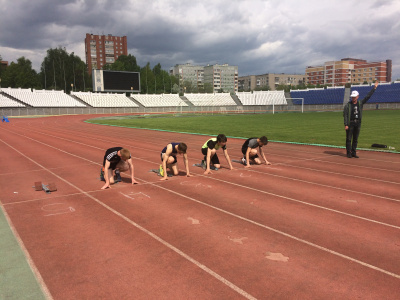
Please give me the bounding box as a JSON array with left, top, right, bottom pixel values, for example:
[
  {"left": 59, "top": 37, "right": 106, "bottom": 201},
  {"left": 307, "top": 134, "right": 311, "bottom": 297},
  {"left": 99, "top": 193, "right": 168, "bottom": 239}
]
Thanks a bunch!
[{"left": 0, "top": 0, "right": 400, "bottom": 80}]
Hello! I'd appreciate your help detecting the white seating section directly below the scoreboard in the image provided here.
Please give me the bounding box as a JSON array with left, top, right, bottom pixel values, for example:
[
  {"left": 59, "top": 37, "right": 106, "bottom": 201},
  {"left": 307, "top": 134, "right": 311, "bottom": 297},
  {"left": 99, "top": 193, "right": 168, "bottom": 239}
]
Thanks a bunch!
[{"left": 71, "top": 92, "right": 139, "bottom": 107}]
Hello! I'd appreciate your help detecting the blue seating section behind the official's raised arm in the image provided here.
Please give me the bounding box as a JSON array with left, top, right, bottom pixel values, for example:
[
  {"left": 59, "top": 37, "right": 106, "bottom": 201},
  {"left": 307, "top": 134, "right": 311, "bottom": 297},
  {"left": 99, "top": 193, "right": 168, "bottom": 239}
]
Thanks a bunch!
[{"left": 351, "top": 82, "right": 400, "bottom": 103}]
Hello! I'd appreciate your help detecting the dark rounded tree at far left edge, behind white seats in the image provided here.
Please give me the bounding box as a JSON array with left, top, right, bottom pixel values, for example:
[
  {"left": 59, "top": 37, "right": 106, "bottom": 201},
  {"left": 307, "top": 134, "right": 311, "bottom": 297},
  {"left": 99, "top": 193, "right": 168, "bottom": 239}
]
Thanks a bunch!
[{"left": 1, "top": 57, "right": 41, "bottom": 89}]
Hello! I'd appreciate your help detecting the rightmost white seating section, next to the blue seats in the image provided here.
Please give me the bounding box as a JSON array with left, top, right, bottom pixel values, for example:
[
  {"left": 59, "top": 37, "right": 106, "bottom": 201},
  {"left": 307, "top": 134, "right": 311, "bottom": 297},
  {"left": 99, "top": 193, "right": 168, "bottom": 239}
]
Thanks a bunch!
[{"left": 236, "top": 91, "right": 287, "bottom": 105}]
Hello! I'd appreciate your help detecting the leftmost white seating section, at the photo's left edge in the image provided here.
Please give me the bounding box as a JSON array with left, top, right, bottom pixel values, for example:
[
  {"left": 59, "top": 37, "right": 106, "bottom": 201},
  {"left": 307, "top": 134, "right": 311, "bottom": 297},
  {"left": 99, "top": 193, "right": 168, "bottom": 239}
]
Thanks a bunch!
[{"left": 2, "top": 88, "right": 85, "bottom": 107}]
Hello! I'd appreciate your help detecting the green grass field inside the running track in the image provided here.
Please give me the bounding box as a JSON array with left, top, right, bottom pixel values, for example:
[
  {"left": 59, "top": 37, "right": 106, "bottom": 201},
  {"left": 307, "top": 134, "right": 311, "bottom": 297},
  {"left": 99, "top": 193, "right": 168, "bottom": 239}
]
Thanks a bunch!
[{"left": 88, "top": 110, "right": 400, "bottom": 152}]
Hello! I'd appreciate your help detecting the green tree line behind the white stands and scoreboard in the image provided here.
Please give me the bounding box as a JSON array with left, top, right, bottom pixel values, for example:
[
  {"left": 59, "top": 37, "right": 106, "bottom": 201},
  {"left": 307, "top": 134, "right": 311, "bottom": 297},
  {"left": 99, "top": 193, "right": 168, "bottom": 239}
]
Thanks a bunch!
[{"left": 0, "top": 47, "right": 178, "bottom": 94}]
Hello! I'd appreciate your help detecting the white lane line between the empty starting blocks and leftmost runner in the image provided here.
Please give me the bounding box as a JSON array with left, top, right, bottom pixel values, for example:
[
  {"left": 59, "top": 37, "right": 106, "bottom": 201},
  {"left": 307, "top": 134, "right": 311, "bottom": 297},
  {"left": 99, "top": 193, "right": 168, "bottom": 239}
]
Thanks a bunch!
[{"left": 1, "top": 140, "right": 256, "bottom": 299}]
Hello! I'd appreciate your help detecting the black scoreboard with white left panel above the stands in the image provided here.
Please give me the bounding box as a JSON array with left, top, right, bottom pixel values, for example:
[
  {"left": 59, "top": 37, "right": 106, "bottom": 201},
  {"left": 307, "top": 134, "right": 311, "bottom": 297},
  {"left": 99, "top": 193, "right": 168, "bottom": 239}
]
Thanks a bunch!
[{"left": 92, "top": 70, "right": 140, "bottom": 92}]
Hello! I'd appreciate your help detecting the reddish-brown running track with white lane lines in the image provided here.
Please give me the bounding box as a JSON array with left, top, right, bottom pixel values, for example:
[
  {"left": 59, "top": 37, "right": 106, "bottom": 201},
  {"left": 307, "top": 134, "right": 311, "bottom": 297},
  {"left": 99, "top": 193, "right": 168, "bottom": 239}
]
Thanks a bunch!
[{"left": 0, "top": 116, "right": 400, "bottom": 299}]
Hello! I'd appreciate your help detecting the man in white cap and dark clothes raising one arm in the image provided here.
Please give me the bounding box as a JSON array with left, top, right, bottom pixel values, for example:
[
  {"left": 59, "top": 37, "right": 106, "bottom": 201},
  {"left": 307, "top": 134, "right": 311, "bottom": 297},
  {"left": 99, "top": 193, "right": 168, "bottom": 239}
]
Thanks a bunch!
[{"left": 343, "top": 81, "right": 379, "bottom": 158}]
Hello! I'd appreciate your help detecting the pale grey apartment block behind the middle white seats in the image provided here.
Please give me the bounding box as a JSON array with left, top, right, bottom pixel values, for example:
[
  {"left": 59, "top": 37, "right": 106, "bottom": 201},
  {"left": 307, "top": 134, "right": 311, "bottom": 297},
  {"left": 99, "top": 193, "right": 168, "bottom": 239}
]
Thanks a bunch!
[{"left": 172, "top": 64, "right": 238, "bottom": 92}]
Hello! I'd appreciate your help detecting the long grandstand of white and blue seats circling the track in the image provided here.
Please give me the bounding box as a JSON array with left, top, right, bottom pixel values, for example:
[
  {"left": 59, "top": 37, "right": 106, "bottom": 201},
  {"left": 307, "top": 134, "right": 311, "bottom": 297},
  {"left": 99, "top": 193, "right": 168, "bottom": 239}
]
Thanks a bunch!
[{"left": 0, "top": 82, "right": 400, "bottom": 116}]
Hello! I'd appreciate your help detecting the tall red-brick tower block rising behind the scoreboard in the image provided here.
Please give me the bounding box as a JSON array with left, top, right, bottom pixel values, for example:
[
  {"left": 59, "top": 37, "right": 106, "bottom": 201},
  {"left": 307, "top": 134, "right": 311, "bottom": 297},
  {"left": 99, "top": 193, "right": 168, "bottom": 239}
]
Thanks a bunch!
[{"left": 85, "top": 33, "right": 128, "bottom": 74}]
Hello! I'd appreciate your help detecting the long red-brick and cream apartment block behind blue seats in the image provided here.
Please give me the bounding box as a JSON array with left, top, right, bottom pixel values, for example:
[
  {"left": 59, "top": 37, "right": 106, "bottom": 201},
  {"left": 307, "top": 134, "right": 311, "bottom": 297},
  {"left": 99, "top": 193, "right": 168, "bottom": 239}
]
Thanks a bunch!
[{"left": 306, "top": 58, "right": 392, "bottom": 86}]
